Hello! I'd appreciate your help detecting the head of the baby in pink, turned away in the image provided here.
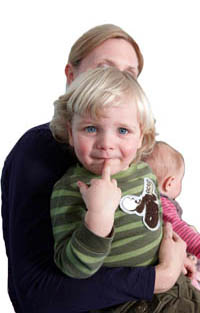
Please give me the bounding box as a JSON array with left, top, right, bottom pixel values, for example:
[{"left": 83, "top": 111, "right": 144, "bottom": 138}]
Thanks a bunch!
[{"left": 143, "top": 141, "right": 185, "bottom": 199}]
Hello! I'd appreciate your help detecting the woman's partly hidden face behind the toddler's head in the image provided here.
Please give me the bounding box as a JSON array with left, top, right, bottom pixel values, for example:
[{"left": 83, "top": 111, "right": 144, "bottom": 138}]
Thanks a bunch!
[{"left": 66, "top": 38, "right": 138, "bottom": 83}]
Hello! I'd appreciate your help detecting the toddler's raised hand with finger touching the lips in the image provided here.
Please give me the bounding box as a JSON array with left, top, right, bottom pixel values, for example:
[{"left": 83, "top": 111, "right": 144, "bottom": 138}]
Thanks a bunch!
[{"left": 78, "top": 161, "right": 121, "bottom": 237}]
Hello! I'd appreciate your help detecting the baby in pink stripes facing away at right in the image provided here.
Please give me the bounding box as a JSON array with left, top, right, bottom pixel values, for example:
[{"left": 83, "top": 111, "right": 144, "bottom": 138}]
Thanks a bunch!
[{"left": 143, "top": 141, "right": 200, "bottom": 289}]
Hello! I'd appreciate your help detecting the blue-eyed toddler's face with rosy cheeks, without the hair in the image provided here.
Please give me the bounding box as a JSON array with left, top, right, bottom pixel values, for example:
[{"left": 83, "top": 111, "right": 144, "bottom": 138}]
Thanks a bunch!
[{"left": 68, "top": 97, "right": 142, "bottom": 175}]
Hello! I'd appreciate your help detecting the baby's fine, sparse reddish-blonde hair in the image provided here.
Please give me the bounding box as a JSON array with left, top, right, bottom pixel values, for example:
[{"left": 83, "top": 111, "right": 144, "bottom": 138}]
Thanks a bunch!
[{"left": 143, "top": 141, "right": 184, "bottom": 184}]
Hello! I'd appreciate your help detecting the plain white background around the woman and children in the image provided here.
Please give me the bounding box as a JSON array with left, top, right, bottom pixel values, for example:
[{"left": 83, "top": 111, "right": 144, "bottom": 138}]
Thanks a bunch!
[{"left": 0, "top": 0, "right": 200, "bottom": 313}]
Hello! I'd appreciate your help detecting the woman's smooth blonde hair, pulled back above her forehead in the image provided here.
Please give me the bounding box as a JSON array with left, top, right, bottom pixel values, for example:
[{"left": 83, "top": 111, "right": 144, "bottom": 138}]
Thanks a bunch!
[{"left": 68, "top": 24, "right": 144, "bottom": 74}]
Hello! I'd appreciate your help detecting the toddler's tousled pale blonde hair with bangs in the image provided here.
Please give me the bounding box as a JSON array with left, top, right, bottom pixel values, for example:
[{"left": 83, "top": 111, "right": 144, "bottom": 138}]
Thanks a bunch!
[{"left": 50, "top": 67, "right": 155, "bottom": 160}]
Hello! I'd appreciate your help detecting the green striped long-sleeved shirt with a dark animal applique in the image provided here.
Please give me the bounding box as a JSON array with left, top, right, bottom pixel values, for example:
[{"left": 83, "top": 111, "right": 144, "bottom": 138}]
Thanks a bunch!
[{"left": 51, "top": 162, "right": 162, "bottom": 278}]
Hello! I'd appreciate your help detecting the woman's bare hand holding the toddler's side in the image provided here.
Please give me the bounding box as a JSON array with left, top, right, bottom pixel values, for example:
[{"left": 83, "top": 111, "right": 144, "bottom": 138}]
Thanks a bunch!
[{"left": 154, "top": 223, "right": 186, "bottom": 293}]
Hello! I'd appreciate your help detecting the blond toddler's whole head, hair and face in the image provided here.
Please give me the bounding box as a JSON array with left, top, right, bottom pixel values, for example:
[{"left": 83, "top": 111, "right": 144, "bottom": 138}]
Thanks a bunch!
[{"left": 50, "top": 68, "right": 155, "bottom": 174}]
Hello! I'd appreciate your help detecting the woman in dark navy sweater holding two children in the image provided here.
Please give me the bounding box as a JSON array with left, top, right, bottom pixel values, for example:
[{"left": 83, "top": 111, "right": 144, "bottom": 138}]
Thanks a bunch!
[{"left": 2, "top": 25, "right": 190, "bottom": 313}]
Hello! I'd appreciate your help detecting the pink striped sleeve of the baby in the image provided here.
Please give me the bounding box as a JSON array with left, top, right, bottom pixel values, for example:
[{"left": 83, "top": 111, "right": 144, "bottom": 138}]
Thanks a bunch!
[{"left": 161, "top": 197, "right": 200, "bottom": 258}]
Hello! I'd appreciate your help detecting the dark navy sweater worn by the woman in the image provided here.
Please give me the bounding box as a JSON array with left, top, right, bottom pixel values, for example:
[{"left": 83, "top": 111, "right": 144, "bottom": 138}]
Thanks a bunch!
[{"left": 1, "top": 124, "right": 155, "bottom": 313}]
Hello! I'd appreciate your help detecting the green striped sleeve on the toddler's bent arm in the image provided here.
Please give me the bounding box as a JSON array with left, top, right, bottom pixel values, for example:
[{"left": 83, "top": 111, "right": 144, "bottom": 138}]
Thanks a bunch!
[{"left": 51, "top": 173, "right": 113, "bottom": 278}]
